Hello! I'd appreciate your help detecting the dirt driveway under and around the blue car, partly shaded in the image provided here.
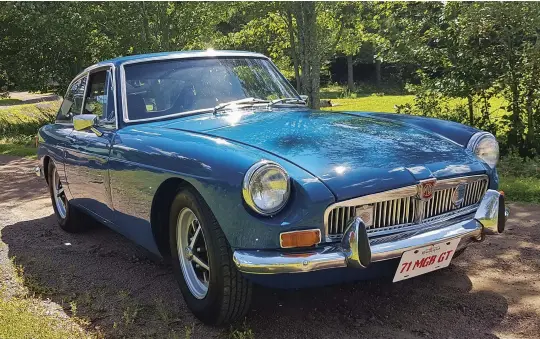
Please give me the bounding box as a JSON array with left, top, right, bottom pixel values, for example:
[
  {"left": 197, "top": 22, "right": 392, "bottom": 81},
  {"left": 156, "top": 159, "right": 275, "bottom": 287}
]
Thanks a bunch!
[{"left": 0, "top": 156, "right": 540, "bottom": 339}]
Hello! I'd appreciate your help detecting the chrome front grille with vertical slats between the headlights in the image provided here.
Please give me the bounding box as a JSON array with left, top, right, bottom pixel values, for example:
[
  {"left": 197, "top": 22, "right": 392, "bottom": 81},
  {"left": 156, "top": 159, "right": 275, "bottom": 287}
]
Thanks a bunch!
[{"left": 325, "top": 175, "right": 488, "bottom": 241}]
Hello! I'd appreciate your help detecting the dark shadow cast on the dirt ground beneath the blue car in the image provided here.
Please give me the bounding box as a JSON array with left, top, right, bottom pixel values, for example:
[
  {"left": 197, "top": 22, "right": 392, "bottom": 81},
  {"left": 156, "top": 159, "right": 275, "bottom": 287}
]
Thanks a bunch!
[{"left": 2, "top": 215, "right": 508, "bottom": 338}]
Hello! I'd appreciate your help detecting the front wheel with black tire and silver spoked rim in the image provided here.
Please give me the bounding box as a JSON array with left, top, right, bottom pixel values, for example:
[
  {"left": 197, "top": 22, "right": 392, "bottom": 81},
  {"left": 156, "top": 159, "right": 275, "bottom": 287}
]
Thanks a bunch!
[{"left": 169, "top": 189, "right": 252, "bottom": 325}]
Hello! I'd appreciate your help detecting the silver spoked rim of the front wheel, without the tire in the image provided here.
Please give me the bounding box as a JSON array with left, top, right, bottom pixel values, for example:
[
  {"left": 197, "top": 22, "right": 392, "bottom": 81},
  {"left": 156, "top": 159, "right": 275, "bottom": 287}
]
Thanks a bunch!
[{"left": 176, "top": 207, "right": 210, "bottom": 299}]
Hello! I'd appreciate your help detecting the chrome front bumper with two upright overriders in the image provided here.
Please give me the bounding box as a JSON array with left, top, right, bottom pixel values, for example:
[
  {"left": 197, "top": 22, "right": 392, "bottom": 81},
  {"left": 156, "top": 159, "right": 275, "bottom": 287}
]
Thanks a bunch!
[{"left": 233, "top": 190, "right": 509, "bottom": 274}]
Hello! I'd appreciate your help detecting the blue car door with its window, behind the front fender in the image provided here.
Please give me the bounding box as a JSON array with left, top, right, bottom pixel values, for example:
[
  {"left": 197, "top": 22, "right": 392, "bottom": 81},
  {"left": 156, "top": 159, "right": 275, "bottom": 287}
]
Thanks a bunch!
[{"left": 65, "top": 67, "right": 116, "bottom": 221}]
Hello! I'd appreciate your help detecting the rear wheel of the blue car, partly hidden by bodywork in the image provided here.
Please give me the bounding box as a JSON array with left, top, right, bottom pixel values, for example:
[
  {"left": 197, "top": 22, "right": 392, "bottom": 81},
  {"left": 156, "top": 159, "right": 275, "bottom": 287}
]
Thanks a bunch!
[{"left": 47, "top": 161, "right": 87, "bottom": 232}]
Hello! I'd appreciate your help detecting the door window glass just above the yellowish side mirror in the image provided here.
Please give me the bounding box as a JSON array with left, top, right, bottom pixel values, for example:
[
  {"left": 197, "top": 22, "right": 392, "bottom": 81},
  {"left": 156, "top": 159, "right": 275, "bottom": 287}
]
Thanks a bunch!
[{"left": 84, "top": 70, "right": 115, "bottom": 122}]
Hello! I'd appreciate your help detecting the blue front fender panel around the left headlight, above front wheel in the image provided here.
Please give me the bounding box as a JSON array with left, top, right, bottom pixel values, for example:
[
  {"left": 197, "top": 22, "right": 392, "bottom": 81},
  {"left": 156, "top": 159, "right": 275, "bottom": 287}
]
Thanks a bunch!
[{"left": 110, "top": 125, "right": 334, "bottom": 249}]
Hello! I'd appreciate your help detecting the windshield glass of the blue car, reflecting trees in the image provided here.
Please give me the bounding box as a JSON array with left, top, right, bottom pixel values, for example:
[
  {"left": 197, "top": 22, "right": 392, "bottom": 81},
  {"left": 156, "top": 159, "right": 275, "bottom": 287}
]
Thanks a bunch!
[{"left": 124, "top": 57, "right": 298, "bottom": 120}]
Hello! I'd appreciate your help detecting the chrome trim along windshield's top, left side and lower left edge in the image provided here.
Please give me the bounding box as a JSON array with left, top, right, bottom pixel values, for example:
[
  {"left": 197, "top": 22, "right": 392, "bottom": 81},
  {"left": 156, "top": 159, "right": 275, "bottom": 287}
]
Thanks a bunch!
[{"left": 120, "top": 50, "right": 272, "bottom": 123}]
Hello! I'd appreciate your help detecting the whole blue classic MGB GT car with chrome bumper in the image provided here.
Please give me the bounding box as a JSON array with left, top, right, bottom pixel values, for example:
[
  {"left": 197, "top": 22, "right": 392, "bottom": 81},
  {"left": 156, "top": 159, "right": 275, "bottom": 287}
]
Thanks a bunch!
[{"left": 36, "top": 50, "right": 508, "bottom": 324}]
